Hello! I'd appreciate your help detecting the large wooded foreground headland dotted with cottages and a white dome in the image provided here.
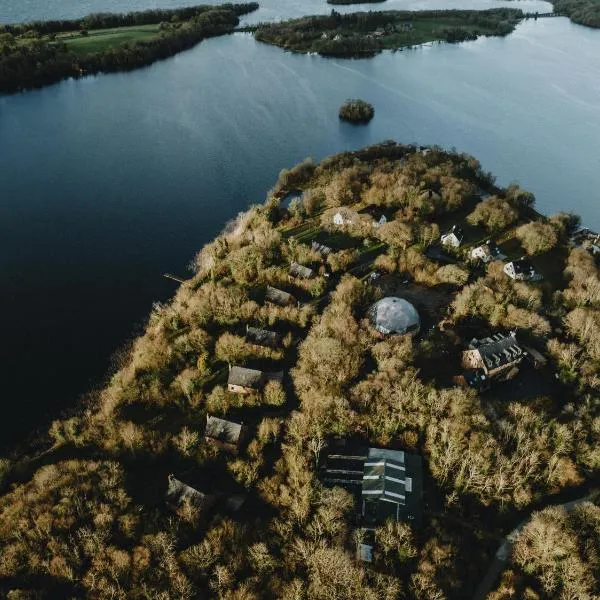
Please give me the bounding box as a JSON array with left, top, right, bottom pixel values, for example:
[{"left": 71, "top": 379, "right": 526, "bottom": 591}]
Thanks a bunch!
[{"left": 0, "top": 142, "right": 600, "bottom": 600}]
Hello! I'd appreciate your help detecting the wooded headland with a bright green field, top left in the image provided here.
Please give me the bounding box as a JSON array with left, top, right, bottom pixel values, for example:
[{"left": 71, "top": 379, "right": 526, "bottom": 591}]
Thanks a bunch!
[{"left": 0, "top": 3, "right": 258, "bottom": 93}]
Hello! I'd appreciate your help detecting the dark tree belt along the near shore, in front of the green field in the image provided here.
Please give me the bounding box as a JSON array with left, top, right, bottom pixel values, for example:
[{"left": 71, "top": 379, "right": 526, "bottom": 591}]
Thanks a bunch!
[{"left": 0, "top": 3, "right": 258, "bottom": 93}]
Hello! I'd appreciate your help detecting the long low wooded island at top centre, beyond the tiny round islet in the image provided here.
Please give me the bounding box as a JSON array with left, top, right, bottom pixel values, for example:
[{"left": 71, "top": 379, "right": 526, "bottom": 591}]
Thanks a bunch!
[{"left": 254, "top": 8, "right": 524, "bottom": 58}]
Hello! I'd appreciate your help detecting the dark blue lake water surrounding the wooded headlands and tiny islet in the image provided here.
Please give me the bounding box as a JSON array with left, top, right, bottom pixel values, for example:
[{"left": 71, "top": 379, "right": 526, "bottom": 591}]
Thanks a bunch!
[{"left": 0, "top": 0, "right": 600, "bottom": 450}]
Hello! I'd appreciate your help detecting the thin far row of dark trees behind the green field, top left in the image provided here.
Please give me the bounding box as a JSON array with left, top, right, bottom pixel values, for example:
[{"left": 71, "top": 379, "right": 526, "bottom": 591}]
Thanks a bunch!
[{"left": 0, "top": 2, "right": 258, "bottom": 36}]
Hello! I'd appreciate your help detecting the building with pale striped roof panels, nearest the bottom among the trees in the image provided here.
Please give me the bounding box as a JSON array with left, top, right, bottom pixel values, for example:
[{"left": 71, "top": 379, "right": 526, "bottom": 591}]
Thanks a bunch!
[{"left": 322, "top": 448, "right": 423, "bottom": 527}]
